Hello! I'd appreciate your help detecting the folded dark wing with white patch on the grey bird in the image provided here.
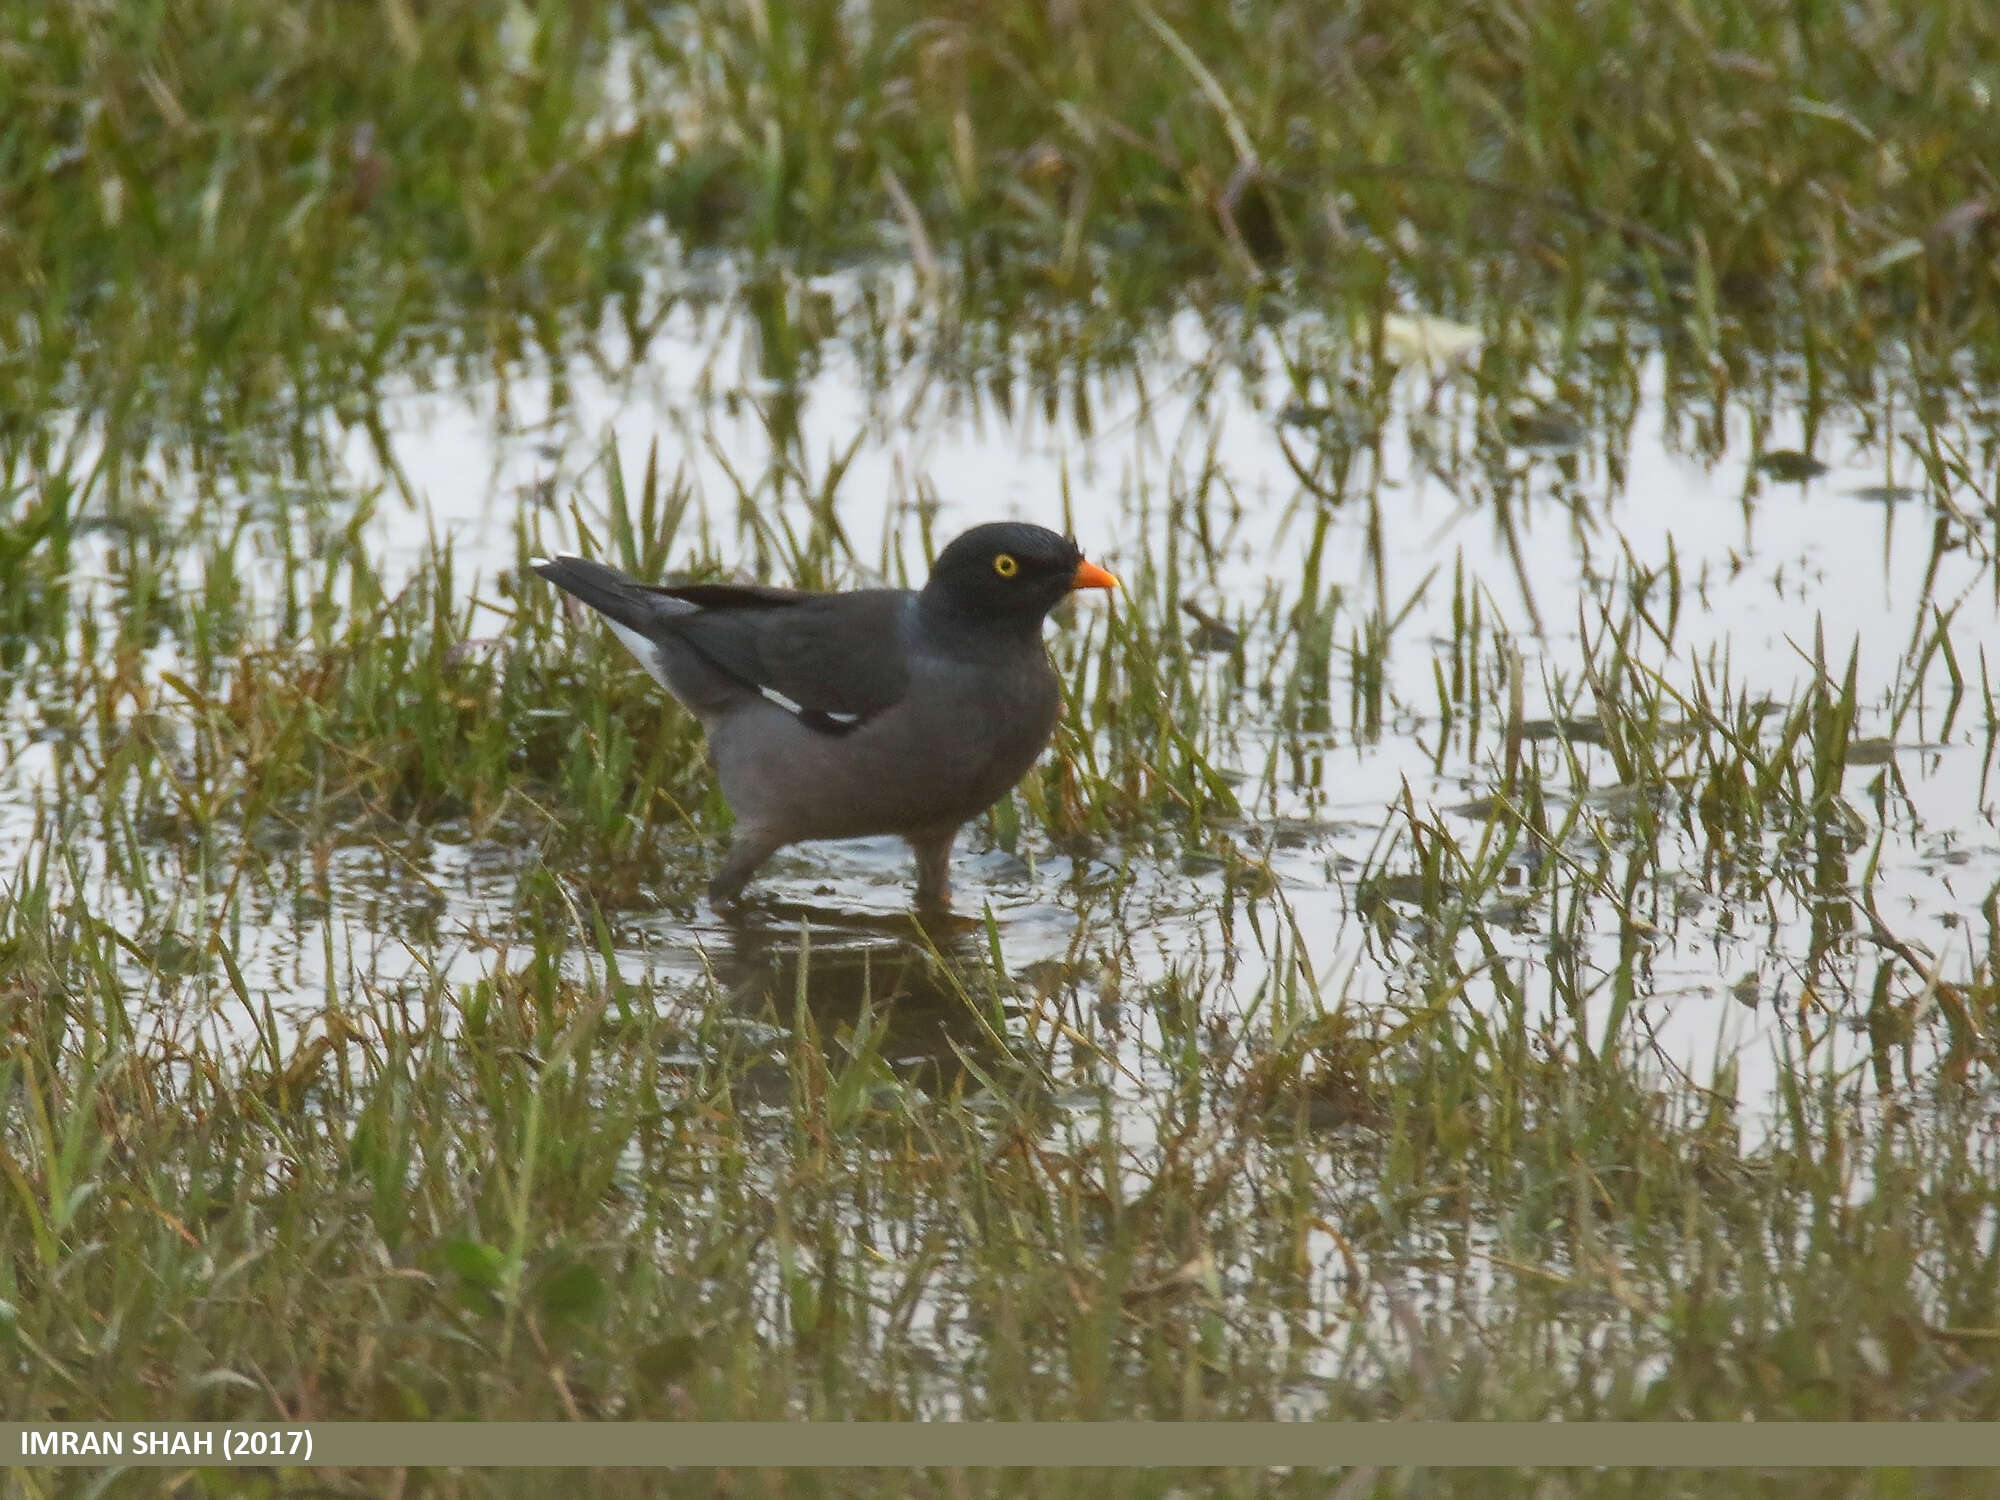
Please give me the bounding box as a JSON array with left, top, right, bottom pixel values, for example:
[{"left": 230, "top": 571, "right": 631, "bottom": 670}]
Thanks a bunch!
[{"left": 670, "top": 584, "right": 910, "bottom": 734}]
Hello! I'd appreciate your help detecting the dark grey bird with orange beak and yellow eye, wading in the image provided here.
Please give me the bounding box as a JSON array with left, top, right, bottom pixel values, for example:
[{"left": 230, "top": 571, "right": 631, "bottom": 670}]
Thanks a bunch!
[{"left": 528, "top": 522, "right": 1120, "bottom": 910}]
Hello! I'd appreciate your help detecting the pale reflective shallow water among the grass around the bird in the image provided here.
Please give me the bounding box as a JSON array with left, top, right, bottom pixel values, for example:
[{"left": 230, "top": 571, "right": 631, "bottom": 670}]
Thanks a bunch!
[{"left": 0, "top": 276, "right": 2000, "bottom": 1136}]
